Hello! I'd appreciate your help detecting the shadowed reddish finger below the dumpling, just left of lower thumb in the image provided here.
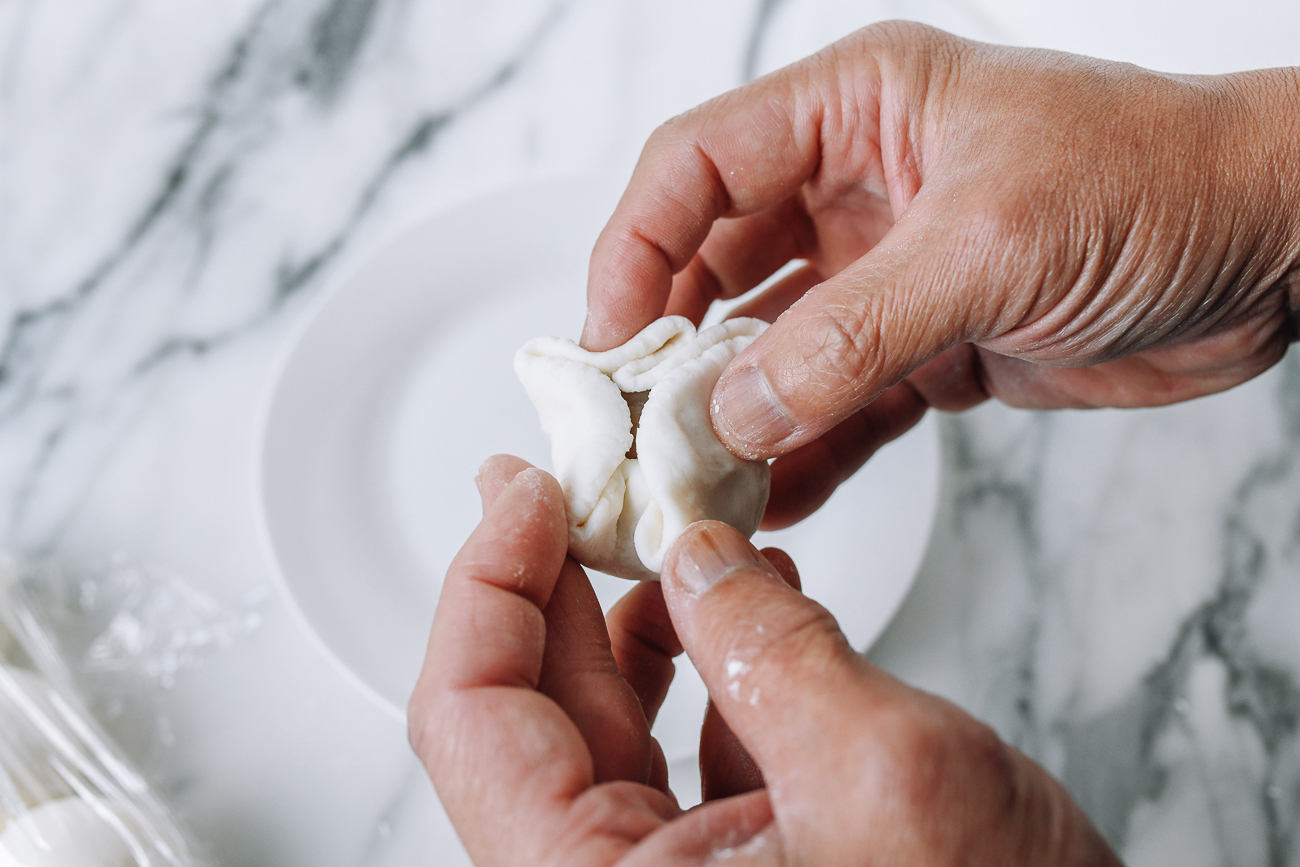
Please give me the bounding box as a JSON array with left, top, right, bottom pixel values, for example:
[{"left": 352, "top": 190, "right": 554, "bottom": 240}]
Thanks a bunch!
[{"left": 606, "top": 581, "right": 681, "bottom": 725}]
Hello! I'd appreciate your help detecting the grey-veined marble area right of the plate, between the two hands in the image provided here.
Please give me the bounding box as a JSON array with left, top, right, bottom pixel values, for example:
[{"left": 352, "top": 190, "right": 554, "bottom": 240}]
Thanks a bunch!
[{"left": 874, "top": 352, "right": 1300, "bottom": 867}]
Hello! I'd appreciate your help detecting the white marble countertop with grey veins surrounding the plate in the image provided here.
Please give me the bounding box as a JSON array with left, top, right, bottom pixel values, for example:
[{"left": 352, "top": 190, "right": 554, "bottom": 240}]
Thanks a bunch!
[{"left": 0, "top": 0, "right": 1300, "bottom": 867}]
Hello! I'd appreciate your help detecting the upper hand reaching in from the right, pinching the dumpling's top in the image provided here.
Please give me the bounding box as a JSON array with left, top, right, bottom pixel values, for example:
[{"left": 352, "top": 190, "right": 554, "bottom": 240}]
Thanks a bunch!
[{"left": 584, "top": 22, "right": 1300, "bottom": 524}]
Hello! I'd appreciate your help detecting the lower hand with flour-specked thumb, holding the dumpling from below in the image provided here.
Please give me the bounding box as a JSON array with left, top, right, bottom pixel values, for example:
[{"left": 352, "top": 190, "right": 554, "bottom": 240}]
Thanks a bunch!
[{"left": 408, "top": 458, "right": 1118, "bottom": 867}]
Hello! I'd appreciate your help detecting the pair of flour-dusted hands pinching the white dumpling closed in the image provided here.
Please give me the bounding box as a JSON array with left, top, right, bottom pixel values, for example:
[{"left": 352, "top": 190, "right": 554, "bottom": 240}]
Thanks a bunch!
[{"left": 410, "top": 25, "right": 1300, "bottom": 864}]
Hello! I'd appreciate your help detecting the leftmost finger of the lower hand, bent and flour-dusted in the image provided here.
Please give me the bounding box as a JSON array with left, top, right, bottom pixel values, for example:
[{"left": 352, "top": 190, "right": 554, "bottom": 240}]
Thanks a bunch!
[{"left": 407, "top": 469, "right": 593, "bottom": 863}]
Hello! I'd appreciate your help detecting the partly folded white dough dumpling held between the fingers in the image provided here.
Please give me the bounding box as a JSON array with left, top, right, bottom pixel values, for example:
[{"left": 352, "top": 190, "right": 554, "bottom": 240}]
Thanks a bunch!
[{"left": 515, "top": 316, "right": 771, "bottom": 581}]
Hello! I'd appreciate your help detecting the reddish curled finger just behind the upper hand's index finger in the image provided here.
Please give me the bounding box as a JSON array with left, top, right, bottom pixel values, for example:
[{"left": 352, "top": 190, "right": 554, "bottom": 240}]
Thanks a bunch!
[{"left": 664, "top": 198, "right": 816, "bottom": 325}]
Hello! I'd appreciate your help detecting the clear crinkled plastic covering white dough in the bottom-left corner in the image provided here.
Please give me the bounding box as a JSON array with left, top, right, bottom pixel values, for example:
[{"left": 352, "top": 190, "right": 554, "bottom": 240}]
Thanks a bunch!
[{"left": 0, "top": 564, "right": 199, "bottom": 867}]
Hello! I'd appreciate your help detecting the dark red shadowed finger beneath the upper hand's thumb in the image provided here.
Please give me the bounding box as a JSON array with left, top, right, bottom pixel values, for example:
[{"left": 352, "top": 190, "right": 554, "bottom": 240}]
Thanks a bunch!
[{"left": 762, "top": 382, "right": 926, "bottom": 530}]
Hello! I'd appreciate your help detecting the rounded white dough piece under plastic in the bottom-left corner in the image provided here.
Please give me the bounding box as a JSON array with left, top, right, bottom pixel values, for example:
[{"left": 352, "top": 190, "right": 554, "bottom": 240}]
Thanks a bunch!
[{"left": 0, "top": 798, "right": 137, "bottom": 867}]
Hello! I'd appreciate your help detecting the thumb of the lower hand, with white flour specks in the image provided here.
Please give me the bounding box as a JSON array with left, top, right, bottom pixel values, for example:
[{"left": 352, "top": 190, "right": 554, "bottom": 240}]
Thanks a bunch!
[{"left": 660, "top": 521, "right": 901, "bottom": 806}]
